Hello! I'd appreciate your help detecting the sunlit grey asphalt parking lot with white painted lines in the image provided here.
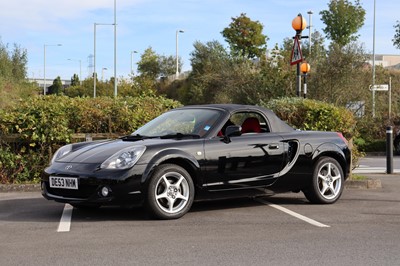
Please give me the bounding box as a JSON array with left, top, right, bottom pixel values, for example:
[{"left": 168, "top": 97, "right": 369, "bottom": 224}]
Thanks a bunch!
[{"left": 0, "top": 174, "right": 400, "bottom": 265}]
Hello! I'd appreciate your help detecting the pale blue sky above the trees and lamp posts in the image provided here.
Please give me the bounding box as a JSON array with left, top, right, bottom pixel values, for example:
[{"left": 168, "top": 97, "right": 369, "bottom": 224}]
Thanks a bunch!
[{"left": 0, "top": 0, "right": 400, "bottom": 79}]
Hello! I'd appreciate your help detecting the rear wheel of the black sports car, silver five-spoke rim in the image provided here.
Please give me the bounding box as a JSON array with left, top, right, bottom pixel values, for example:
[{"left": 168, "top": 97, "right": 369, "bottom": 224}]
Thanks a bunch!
[{"left": 303, "top": 157, "right": 344, "bottom": 204}]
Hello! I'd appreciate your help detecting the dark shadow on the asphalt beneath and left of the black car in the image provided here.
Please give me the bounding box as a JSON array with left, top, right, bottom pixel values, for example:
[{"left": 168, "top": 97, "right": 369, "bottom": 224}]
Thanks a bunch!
[{"left": 0, "top": 194, "right": 308, "bottom": 222}]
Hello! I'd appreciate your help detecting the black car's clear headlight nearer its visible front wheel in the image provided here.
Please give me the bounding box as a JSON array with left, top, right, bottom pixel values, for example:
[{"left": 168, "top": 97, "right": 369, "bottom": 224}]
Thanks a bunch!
[{"left": 100, "top": 146, "right": 146, "bottom": 169}]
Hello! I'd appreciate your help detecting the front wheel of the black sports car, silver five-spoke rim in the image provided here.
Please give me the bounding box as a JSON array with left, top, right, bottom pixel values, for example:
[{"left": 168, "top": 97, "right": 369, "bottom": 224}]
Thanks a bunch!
[{"left": 146, "top": 164, "right": 194, "bottom": 220}]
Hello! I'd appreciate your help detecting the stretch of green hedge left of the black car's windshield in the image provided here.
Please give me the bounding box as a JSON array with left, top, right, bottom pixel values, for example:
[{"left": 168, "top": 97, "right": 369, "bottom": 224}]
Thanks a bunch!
[{"left": 0, "top": 96, "right": 180, "bottom": 183}]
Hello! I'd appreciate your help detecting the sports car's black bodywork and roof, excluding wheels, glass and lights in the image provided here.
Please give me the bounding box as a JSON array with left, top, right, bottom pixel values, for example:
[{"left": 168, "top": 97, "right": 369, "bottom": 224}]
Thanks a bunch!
[{"left": 42, "top": 104, "right": 351, "bottom": 205}]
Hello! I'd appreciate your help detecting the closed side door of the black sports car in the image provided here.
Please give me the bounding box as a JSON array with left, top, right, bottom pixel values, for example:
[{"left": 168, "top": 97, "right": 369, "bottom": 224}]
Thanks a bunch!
[{"left": 204, "top": 112, "right": 285, "bottom": 191}]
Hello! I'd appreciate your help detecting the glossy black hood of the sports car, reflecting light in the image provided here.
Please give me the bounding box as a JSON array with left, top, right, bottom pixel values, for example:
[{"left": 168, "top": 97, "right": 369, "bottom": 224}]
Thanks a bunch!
[{"left": 56, "top": 139, "right": 199, "bottom": 164}]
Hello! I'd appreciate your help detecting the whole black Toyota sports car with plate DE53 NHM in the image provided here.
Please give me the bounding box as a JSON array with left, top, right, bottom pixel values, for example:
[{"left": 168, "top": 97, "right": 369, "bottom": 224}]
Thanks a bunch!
[{"left": 42, "top": 104, "right": 351, "bottom": 219}]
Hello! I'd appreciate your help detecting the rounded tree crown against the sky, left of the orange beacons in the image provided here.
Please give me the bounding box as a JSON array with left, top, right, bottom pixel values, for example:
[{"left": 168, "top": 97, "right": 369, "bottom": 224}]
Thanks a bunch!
[{"left": 221, "top": 13, "right": 268, "bottom": 58}]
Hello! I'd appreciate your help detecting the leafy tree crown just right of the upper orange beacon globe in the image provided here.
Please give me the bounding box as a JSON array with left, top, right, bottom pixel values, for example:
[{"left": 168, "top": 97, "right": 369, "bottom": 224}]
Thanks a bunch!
[{"left": 319, "top": 0, "right": 365, "bottom": 47}]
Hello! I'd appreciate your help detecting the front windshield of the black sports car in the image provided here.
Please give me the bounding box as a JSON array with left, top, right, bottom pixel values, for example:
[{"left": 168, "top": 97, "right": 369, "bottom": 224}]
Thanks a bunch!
[{"left": 132, "top": 109, "right": 221, "bottom": 137}]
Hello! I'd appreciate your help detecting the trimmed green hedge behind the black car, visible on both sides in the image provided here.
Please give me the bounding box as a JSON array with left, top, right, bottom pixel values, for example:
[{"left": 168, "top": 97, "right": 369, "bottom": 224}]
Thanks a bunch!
[{"left": 0, "top": 96, "right": 360, "bottom": 183}]
